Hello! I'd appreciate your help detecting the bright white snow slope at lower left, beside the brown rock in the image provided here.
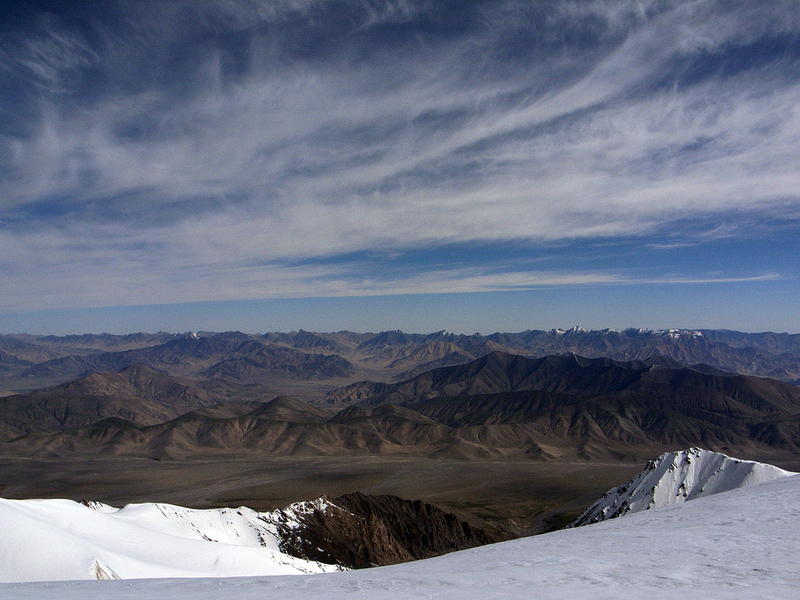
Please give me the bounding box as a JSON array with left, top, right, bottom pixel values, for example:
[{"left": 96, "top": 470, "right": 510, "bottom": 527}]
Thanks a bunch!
[{"left": 0, "top": 499, "right": 338, "bottom": 584}]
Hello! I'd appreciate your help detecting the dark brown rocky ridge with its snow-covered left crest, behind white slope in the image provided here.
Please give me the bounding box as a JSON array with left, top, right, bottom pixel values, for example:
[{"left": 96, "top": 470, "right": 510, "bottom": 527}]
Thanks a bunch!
[{"left": 72, "top": 492, "right": 500, "bottom": 579}]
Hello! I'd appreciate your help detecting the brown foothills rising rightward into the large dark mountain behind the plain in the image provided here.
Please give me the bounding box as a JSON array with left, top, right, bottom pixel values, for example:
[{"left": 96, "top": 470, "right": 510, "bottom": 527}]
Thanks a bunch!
[{"left": 9, "top": 353, "right": 800, "bottom": 459}]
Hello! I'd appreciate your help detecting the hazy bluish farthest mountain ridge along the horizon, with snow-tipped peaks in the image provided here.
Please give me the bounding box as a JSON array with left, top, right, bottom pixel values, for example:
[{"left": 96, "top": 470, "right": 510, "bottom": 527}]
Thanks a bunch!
[{"left": 0, "top": 327, "right": 800, "bottom": 398}]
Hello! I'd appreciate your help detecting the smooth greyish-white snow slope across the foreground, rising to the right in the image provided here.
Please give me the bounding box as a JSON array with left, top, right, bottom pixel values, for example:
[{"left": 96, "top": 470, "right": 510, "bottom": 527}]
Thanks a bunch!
[{"left": 0, "top": 468, "right": 800, "bottom": 600}]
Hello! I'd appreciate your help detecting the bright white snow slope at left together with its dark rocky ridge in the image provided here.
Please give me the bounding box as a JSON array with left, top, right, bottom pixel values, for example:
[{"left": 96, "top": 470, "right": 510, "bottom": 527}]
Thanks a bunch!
[{"left": 0, "top": 493, "right": 499, "bottom": 584}]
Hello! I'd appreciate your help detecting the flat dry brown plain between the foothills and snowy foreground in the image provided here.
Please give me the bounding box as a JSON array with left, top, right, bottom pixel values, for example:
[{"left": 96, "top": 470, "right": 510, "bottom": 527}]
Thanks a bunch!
[{"left": 0, "top": 454, "right": 660, "bottom": 536}]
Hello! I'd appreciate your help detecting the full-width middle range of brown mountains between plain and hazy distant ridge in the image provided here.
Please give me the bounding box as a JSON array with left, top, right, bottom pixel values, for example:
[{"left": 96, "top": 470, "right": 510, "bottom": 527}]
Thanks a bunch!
[{"left": 9, "top": 352, "right": 800, "bottom": 460}]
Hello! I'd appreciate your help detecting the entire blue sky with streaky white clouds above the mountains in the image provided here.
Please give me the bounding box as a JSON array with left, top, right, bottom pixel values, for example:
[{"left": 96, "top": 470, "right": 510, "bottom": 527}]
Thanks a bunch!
[{"left": 0, "top": 0, "right": 800, "bottom": 334}]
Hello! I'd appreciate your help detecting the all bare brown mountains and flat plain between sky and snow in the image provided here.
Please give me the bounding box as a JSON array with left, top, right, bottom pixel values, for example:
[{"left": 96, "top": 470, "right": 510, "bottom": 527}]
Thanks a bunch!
[{"left": 0, "top": 328, "right": 800, "bottom": 558}]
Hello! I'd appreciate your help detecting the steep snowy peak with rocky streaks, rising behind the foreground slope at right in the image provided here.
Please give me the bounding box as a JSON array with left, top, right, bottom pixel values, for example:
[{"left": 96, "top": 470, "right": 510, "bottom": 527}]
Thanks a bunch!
[{"left": 571, "top": 448, "right": 795, "bottom": 527}]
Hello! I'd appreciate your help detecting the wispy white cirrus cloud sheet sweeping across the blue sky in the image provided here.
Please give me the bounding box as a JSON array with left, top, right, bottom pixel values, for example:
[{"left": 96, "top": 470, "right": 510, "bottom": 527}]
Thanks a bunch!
[{"left": 0, "top": 1, "right": 800, "bottom": 306}]
